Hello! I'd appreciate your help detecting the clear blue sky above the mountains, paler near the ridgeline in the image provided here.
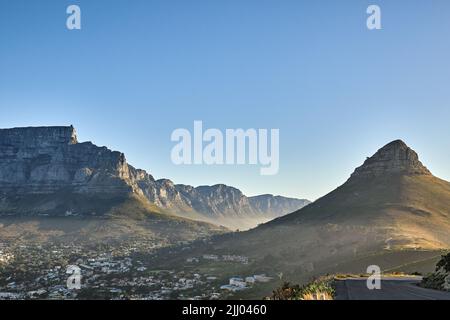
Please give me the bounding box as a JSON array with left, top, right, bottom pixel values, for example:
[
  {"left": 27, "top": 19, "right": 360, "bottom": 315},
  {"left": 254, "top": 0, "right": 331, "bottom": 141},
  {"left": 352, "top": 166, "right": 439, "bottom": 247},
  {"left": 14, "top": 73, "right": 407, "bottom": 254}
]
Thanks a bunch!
[{"left": 0, "top": 0, "right": 450, "bottom": 199}]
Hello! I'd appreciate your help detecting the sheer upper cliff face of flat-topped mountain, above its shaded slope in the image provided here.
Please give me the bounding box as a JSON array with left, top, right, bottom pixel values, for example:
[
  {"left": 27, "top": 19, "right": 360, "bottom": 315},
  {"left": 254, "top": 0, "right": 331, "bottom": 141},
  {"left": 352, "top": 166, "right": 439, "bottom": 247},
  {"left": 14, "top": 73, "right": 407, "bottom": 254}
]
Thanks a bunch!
[{"left": 0, "top": 127, "right": 133, "bottom": 194}]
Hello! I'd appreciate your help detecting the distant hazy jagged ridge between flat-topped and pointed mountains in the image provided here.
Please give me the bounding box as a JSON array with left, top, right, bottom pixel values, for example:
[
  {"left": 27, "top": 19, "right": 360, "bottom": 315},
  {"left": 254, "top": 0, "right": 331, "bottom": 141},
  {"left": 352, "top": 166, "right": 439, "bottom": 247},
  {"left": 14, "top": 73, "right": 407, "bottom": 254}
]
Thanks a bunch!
[{"left": 149, "top": 180, "right": 310, "bottom": 230}]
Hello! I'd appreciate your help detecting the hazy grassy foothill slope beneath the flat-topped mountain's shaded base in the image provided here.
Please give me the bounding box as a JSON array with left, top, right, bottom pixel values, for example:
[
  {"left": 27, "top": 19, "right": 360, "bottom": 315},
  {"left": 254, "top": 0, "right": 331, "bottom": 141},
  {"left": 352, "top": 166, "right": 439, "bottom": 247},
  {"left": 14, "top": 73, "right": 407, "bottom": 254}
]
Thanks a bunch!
[{"left": 0, "top": 194, "right": 225, "bottom": 244}]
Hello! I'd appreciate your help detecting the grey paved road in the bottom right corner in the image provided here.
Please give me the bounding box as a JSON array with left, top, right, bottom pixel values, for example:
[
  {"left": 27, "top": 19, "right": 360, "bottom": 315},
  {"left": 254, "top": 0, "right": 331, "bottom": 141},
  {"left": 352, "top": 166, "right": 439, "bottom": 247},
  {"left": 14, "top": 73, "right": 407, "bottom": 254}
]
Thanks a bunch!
[{"left": 336, "top": 278, "right": 450, "bottom": 300}]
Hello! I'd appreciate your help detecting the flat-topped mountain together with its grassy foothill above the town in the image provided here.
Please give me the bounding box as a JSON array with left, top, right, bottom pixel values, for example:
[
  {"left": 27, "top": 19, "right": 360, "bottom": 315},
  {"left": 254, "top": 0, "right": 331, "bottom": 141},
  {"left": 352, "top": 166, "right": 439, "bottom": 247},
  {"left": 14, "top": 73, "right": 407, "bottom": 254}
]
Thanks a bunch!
[{"left": 0, "top": 127, "right": 225, "bottom": 244}]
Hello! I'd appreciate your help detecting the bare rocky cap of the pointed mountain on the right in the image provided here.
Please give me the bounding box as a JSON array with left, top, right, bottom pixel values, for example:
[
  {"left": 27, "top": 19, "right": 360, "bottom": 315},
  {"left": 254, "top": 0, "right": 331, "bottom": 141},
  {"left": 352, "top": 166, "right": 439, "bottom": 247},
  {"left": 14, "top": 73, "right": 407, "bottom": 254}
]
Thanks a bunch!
[{"left": 351, "top": 140, "right": 431, "bottom": 178}]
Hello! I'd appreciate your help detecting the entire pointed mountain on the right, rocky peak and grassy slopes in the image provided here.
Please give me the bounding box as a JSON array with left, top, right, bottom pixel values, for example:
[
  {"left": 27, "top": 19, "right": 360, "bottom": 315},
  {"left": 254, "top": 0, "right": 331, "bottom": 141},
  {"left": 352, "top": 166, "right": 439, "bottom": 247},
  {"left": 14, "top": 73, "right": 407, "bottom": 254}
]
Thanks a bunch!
[{"left": 189, "top": 140, "right": 450, "bottom": 292}]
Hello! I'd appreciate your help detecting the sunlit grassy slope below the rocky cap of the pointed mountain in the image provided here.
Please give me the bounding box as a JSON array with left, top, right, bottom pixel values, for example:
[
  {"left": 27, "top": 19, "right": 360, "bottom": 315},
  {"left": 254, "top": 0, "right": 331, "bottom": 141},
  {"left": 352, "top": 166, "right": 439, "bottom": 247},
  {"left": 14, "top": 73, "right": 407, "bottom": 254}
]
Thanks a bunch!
[{"left": 220, "top": 172, "right": 450, "bottom": 261}]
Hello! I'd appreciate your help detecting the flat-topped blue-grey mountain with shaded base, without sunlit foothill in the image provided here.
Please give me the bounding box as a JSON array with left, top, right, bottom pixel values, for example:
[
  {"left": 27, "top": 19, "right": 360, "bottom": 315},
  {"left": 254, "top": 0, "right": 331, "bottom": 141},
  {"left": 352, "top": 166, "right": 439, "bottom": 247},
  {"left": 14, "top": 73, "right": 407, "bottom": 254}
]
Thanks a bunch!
[{"left": 0, "top": 127, "right": 154, "bottom": 216}]
